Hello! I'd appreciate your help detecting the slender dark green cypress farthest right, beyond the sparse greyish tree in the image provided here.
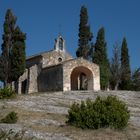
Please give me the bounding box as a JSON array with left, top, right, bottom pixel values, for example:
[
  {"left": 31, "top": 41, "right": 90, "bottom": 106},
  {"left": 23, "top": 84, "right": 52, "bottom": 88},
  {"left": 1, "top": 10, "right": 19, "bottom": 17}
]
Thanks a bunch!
[{"left": 120, "top": 38, "right": 131, "bottom": 90}]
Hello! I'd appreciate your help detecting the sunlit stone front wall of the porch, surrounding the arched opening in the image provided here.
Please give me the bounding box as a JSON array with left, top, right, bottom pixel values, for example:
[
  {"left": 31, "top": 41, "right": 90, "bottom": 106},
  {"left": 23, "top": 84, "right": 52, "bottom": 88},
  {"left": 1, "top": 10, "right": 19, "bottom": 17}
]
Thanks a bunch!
[{"left": 63, "top": 58, "right": 100, "bottom": 91}]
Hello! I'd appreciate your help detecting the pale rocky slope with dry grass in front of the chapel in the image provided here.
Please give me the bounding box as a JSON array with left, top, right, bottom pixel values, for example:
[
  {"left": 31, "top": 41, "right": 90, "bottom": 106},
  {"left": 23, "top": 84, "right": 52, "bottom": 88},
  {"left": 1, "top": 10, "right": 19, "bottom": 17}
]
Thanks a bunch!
[{"left": 0, "top": 91, "right": 140, "bottom": 140}]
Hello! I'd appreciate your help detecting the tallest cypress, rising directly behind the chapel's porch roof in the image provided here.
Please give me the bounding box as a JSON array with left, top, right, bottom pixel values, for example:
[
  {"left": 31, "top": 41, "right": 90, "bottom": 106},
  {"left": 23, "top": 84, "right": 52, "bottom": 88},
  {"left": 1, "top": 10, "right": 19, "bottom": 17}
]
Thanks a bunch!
[{"left": 76, "top": 6, "right": 93, "bottom": 59}]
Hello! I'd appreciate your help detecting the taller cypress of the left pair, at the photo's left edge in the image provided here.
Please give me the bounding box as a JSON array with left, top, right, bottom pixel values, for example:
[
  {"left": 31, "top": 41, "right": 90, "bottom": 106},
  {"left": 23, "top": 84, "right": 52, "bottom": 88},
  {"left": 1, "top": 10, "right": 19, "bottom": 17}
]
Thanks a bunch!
[{"left": 0, "top": 9, "right": 16, "bottom": 86}]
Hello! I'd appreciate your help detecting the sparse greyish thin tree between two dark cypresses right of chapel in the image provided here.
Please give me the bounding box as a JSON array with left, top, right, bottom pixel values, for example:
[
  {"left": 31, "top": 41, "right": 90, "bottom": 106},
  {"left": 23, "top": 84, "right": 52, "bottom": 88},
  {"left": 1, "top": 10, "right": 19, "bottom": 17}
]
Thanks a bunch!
[{"left": 110, "top": 43, "right": 121, "bottom": 90}]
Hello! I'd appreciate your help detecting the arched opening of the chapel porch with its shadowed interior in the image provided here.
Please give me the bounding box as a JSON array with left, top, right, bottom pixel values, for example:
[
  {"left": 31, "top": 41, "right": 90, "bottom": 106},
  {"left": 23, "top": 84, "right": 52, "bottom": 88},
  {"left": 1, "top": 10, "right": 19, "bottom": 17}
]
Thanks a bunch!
[{"left": 70, "top": 66, "right": 93, "bottom": 90}]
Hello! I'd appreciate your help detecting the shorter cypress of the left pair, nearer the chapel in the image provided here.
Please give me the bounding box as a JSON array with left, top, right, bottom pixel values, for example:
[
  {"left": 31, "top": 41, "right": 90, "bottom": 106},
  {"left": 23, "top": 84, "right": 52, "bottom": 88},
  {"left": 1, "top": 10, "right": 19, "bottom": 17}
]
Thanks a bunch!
[{"left": 11, "top": 27, "right": 26, "bottom": 81}]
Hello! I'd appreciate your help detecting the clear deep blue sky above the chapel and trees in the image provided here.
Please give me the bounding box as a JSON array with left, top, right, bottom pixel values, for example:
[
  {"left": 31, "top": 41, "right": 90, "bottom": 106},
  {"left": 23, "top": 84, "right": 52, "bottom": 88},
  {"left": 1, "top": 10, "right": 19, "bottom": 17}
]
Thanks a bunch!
[{"left": 0, "top": 0, "right": 140, "bottom": 69}]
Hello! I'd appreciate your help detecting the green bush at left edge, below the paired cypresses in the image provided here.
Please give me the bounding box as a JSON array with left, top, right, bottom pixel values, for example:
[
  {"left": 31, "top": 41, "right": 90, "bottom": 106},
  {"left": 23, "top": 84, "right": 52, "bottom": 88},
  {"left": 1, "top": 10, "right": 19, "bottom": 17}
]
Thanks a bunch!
[{"left": 0, "top": 87, "right": 16, "bottom": 99}]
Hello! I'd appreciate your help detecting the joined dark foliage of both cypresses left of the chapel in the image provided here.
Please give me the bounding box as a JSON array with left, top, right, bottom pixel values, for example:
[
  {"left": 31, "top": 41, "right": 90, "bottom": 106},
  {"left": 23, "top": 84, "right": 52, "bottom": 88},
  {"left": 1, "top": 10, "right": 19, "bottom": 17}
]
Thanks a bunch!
[{"left": 0, "top": 9, "right": 26, "bottom": 87}]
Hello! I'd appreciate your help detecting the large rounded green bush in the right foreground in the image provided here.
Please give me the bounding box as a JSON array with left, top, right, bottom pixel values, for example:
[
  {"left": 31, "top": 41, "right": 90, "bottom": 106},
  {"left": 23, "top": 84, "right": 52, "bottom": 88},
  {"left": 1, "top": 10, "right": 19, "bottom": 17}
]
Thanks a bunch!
[{"left": 67, "top": 96, "right": 130, "bottom": 129}]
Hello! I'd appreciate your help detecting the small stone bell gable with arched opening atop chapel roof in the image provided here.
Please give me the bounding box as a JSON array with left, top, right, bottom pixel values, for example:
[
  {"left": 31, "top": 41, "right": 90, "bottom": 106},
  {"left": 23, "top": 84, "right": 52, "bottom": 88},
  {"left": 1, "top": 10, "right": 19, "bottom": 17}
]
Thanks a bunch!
[{"left": 54, "top": 35, "right": 65, "bottom": 52}]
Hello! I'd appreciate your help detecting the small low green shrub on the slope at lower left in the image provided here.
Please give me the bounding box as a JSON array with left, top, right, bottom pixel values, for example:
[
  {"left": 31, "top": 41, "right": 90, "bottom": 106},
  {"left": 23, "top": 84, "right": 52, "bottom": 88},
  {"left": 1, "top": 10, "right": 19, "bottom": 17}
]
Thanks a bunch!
[{"left": 1, "top": 111, "right": 18, "bottom": 123}]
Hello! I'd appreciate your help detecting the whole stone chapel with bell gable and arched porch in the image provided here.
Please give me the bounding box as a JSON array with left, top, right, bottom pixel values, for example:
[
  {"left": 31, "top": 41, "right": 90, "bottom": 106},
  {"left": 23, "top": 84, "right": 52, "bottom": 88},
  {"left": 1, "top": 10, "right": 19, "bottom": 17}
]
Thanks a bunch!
[{"left": 15, "top": 35, "right": 100, "bottom": 94}]
